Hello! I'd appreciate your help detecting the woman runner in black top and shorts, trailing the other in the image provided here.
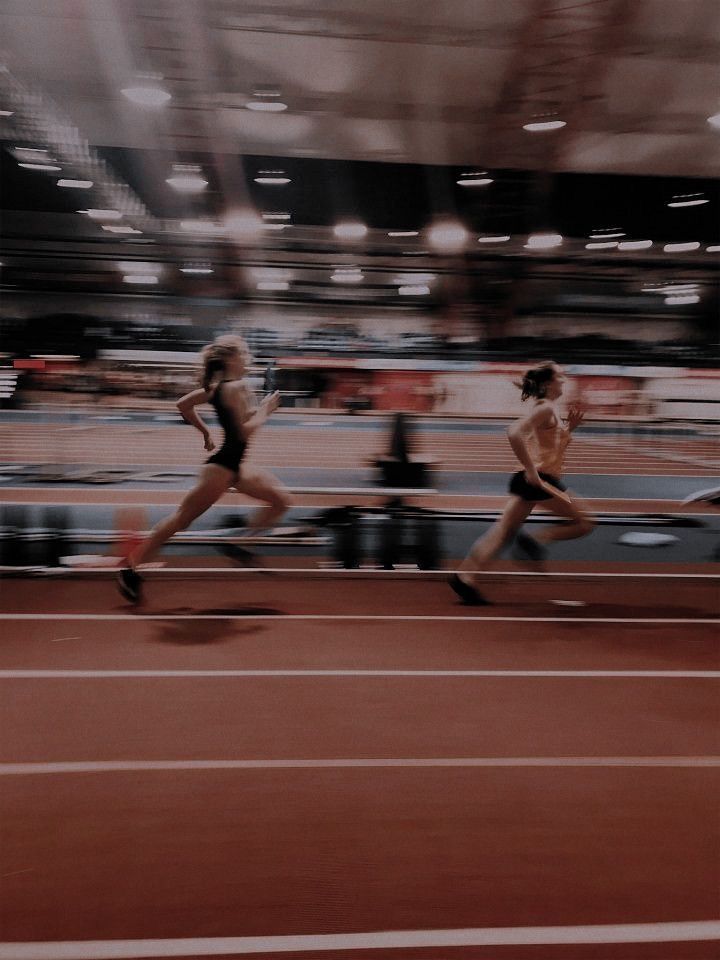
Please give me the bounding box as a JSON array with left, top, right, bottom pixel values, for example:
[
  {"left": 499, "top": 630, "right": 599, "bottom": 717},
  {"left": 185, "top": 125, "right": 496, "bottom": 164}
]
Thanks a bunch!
[{"left": 118, "top": 336, "right": 291, "bottom": 603}]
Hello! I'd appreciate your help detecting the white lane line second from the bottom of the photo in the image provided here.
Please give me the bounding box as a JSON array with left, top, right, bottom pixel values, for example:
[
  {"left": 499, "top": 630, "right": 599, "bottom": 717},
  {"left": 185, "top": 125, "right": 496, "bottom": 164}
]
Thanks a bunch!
[{"left": 0, "top": 756, "right": 720, "bottom": 777}]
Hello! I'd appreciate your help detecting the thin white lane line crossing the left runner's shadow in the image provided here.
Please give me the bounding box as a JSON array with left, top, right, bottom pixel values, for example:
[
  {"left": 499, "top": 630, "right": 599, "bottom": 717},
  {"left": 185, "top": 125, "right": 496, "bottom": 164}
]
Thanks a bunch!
[{"left": 0, "top": 610, "right": 720, "bottom": 625}]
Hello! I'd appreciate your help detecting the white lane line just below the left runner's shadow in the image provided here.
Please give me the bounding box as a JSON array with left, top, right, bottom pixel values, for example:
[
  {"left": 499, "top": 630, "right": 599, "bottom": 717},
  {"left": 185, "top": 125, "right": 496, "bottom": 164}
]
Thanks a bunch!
[{"left": 0, "top": 670, "right": 720, "bottom": 680}]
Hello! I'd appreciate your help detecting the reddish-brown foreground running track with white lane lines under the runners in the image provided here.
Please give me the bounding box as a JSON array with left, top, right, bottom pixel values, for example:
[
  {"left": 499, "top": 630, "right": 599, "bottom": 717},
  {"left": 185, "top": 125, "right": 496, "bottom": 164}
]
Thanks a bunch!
[{"left": 0, "top": 572, "right": 720, "bottom": 960}]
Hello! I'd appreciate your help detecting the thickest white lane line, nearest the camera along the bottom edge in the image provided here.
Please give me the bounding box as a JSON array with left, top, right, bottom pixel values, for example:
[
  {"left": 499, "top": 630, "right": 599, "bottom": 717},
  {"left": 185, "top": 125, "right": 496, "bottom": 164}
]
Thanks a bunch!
[{"left": 0, "top": 920, "right": 720, "bottom": 960}]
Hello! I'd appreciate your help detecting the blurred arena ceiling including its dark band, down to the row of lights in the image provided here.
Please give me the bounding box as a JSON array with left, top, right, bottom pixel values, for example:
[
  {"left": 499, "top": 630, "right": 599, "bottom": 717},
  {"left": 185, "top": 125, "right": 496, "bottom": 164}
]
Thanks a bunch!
[{"left": 0, "top": 0, "right": 720, "bottom": 302}]
